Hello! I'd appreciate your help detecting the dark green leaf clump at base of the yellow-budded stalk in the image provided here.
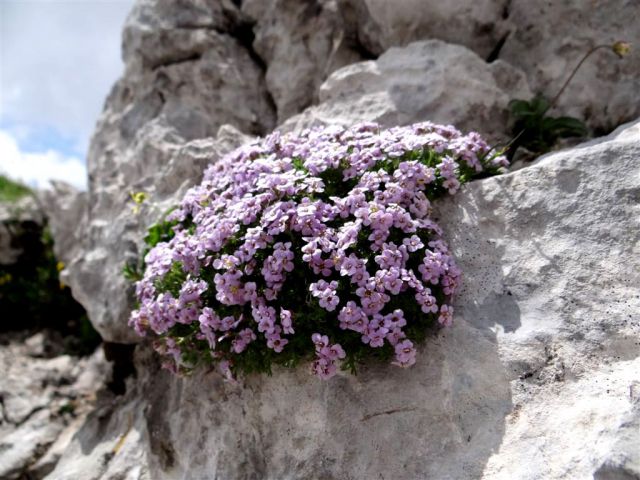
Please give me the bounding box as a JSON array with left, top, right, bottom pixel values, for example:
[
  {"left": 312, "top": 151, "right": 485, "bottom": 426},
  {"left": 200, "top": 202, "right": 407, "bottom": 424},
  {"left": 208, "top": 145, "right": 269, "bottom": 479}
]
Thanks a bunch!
[{"left": 509, "top": 95, "right": 588, "bottom": 157}]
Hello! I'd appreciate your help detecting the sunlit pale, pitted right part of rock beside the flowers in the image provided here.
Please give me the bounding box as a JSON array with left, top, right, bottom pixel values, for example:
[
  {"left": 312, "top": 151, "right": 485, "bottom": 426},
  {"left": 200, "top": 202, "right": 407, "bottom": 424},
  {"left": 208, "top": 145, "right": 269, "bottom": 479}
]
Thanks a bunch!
[{"left": 440, "top": 118, "right": 640, "bottom": 479}]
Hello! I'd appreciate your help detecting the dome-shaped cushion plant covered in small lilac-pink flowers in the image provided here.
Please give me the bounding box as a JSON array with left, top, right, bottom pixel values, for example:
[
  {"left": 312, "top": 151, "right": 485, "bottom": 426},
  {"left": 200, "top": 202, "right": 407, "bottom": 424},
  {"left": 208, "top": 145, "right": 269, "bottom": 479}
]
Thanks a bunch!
[{"left": 129, "top": 123, "right": 507, "bottom": 379}]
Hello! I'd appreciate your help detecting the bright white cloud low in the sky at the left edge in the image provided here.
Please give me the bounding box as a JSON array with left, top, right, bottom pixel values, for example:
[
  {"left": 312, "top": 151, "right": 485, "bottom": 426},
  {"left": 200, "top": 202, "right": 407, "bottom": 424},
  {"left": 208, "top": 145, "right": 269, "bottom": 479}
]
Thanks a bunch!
[{"left": 0, "top": 130, "right": 87, "bottom": 190}]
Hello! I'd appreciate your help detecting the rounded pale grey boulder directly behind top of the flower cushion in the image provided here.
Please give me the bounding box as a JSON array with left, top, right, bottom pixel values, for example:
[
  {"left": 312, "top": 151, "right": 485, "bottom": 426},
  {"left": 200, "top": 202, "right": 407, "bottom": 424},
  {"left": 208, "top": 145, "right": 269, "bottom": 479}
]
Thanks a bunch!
[{"left": 282, "top": 40, "right": 530, "bottom": 139}]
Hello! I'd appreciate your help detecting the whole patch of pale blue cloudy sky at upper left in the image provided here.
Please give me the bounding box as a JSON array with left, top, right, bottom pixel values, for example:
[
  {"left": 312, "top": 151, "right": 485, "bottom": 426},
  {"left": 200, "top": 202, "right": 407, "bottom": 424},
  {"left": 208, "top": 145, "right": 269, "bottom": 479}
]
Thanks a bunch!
[{"left": 0, "top": 0, "right": 133, "bottom": 188}]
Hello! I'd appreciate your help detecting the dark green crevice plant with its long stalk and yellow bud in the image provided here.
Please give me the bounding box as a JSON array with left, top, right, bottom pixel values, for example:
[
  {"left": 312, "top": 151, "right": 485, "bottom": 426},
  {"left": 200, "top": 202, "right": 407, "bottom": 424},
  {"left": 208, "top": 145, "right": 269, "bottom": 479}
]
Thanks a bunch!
[{"left": 507, "top": 42, "right": 631, "bottom": 158}]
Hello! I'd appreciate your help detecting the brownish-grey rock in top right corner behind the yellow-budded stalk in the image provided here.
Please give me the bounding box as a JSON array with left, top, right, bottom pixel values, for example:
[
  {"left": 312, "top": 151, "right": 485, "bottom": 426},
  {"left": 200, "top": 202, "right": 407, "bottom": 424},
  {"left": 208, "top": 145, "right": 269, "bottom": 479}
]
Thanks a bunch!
[{"left": 500, "top": 0, "right": 640, "bottom": 132}]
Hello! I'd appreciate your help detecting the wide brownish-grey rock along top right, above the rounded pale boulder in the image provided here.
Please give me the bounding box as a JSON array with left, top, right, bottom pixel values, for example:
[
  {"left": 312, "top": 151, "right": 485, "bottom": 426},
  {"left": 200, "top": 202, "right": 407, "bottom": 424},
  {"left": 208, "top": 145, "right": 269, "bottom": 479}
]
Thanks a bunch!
[{"left": 339, "top": 0, "right": 640, "bottom": 132}]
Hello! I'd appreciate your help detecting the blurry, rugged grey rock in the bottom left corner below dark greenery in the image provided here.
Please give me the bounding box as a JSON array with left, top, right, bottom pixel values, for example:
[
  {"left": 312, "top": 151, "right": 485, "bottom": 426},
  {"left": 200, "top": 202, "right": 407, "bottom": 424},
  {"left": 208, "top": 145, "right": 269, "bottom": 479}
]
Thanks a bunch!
[{"left": 0, "top": 334, "right": 109, "bottom": 480}]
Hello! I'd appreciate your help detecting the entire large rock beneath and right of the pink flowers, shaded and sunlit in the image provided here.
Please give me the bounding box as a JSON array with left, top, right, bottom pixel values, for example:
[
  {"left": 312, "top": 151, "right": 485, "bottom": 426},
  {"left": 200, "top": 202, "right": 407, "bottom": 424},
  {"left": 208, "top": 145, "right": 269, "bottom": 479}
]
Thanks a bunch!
[{"left": 49, "top": 122, "right": 640, "bottom": 480}]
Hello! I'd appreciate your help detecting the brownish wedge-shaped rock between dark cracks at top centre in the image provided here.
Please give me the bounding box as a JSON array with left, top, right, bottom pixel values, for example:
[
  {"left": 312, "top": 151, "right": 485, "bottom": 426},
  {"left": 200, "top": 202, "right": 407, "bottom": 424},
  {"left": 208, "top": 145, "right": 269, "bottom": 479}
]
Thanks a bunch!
[{"left": 242, "top": 0, "right": 362, "bottom": 122}]
